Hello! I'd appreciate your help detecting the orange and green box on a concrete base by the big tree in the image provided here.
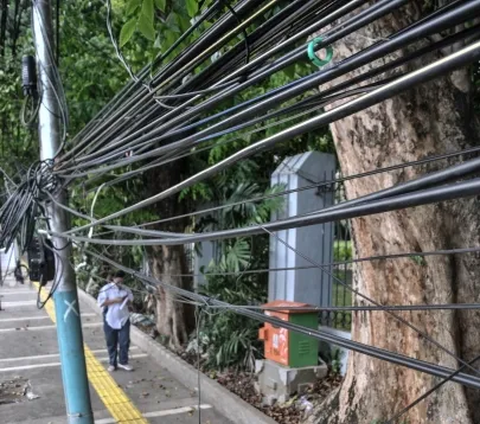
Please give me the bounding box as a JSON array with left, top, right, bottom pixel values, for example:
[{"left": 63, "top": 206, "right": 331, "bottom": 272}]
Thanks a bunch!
[{"left": 259, "top": 300, "right": 318, "bottom": 368}]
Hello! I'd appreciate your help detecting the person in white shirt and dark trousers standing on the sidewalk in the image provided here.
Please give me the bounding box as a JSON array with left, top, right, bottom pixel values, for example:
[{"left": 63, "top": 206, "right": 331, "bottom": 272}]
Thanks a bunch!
[{"left": 97, "top": 271, "right": 133, "bottom": 372}]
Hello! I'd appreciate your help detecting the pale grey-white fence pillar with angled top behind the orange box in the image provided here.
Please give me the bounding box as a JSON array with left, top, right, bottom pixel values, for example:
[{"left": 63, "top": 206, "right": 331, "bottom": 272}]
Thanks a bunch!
[{"left": 268, "top": 152, "right": 336, "bottom": 306}]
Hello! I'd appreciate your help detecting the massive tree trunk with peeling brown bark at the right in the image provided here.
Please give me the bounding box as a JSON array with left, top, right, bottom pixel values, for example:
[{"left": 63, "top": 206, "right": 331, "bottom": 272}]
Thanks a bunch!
[{"left": 309, "top": 1, "right": 480, "bottom": 424}]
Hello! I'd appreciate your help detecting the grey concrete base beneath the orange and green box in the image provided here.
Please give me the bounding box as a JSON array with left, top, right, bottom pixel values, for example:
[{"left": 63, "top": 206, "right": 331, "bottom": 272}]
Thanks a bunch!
[{"left": 255, "top": 359, "right": 328, "bottom": 405}]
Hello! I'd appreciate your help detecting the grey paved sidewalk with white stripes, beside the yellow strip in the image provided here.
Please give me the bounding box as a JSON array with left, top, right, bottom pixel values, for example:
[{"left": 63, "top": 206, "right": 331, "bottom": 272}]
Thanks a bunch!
[{"left": 0, "top": 280, "right": 235, "bottom": 424}]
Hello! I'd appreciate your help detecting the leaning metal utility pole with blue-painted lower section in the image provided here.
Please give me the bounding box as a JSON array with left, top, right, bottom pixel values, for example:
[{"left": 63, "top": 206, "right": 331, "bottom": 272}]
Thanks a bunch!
[{"left": 32, "top": 0, "right": 94, "bottom": 424}]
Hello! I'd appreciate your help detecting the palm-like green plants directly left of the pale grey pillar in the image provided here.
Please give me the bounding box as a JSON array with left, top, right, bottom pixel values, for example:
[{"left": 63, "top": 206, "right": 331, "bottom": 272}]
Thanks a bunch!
[{"left": 189, "top": 173, "right": 283, "bottom": 370}]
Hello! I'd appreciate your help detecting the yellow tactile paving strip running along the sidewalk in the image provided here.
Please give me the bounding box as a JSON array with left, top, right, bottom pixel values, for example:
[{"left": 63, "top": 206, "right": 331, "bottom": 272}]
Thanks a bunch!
[{"left": 34, "top": 283, "right": 148, "bottom": 424}]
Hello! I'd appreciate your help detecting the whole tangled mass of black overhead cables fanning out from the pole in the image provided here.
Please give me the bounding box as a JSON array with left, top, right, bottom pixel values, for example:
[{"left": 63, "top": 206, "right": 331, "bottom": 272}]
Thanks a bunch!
[{"left": 4, "top": 0, "right": 480, "bottom": 420}]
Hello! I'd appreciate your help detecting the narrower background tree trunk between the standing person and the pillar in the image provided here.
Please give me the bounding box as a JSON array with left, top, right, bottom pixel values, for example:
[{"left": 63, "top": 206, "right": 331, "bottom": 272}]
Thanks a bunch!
[{"left": 145, "top": 157, "right": 194, "bottom": 349}]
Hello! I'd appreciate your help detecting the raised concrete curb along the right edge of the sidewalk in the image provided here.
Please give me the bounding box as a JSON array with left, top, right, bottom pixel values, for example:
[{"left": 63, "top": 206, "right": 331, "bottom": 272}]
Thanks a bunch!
[{"left": 78, "top": 288, "right": 277, "bottom": 424}]
